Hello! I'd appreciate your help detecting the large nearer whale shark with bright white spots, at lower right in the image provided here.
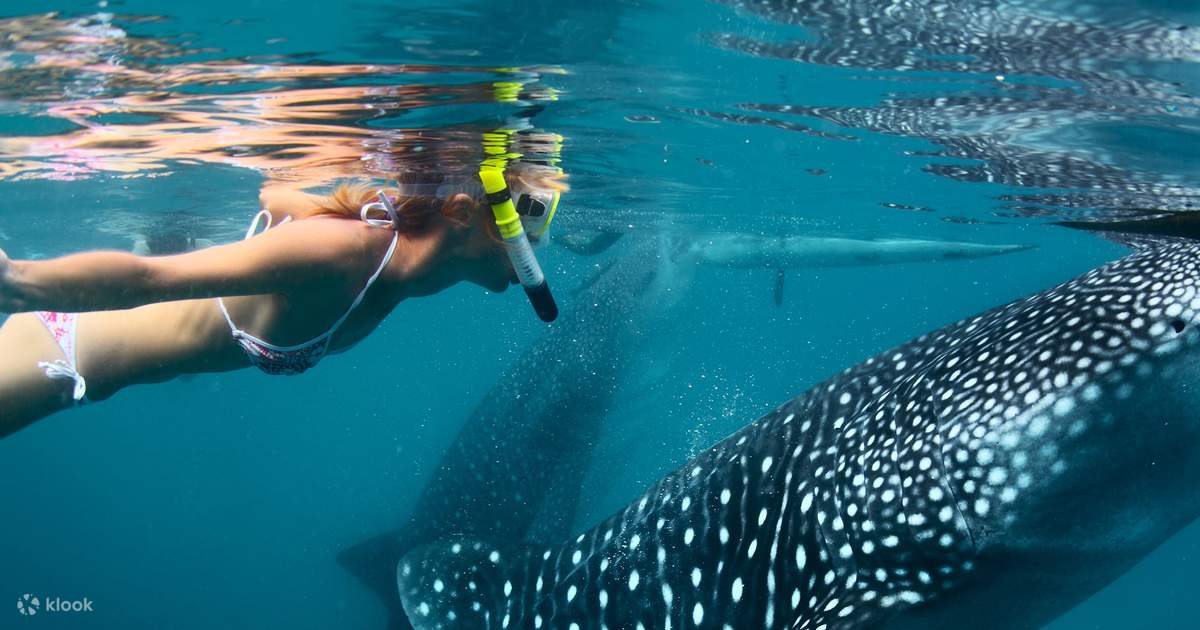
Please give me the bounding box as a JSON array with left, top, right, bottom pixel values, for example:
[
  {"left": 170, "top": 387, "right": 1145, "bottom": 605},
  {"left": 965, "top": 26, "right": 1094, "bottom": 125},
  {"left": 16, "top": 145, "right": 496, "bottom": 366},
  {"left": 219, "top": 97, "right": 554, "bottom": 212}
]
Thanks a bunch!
[{"left": 397, "top": 245, "right": 1200, "bottom": 630}]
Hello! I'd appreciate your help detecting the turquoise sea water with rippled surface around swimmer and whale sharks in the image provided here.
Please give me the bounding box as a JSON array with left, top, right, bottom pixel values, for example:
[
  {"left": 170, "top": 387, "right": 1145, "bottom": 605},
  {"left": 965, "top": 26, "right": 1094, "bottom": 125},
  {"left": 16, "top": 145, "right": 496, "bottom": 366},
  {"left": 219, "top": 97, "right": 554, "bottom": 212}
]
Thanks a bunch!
[{"left": 0, "top": 0, "right": 1200, "bottom": 630}]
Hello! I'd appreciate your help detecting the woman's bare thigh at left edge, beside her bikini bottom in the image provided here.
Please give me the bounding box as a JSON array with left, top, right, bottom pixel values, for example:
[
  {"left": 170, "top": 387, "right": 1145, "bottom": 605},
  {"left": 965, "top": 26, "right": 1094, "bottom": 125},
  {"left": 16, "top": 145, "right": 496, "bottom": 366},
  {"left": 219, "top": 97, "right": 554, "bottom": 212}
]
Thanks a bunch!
[{"left": 0, "top": 313, "right": 74, "bottom": 438}]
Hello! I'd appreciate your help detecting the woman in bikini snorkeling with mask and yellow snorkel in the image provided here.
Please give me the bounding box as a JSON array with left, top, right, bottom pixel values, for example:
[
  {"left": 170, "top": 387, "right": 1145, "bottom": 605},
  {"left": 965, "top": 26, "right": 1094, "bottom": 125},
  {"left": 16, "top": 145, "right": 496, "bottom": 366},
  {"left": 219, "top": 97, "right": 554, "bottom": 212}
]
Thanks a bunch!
[{"left": 0, "top": 163, "right": 566, "bottom": 437}]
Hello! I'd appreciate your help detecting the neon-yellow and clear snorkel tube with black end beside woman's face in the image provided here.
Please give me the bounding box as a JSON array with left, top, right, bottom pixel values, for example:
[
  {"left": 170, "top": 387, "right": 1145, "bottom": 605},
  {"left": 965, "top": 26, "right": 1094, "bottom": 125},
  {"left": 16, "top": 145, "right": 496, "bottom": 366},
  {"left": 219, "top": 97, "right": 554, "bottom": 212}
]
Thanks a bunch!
[{"left": 479, "top": 168, "right": 558, "bottom": 322}]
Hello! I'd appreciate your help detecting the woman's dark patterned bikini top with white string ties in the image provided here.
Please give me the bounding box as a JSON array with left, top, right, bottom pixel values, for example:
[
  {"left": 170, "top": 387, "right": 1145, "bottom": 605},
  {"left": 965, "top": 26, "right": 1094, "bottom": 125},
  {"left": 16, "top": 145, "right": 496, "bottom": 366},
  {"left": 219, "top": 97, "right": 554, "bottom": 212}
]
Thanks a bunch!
[{"left": 217, "top": 210, "right": 400, "bottom": 376}]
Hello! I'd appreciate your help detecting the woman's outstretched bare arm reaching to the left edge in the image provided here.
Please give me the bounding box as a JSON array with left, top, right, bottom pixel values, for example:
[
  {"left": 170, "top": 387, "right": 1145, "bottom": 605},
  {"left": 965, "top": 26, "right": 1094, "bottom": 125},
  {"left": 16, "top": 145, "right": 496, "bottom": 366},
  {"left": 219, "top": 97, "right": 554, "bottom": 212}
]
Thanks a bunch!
[{"left": 0, "top": 220, "right": 366, "bottom": 312}]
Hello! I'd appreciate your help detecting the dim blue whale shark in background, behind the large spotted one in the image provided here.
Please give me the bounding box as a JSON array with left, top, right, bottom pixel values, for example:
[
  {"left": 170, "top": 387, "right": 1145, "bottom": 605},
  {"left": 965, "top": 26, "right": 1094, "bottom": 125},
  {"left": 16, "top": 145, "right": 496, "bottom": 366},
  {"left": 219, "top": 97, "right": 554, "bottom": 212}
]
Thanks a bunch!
[{"left": 338, "top": 240, "right": 678, "bottom": 629}]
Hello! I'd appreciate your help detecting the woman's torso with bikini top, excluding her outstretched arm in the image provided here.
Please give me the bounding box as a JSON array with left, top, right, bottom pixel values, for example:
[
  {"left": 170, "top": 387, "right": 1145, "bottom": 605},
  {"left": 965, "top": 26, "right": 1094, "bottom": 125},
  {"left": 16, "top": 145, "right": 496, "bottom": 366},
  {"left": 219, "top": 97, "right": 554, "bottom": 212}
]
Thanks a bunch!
[{"left": 78, "top": 211, "right": 397, "bottom": 400}]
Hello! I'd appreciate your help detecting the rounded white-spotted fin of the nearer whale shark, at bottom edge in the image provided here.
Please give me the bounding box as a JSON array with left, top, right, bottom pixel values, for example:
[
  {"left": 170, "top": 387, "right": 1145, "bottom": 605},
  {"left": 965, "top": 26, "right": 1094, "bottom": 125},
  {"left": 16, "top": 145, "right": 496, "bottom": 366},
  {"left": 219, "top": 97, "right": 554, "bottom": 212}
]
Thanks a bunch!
[{"left": 396, "top": 539, "right": 532, "bottom": 630}]
